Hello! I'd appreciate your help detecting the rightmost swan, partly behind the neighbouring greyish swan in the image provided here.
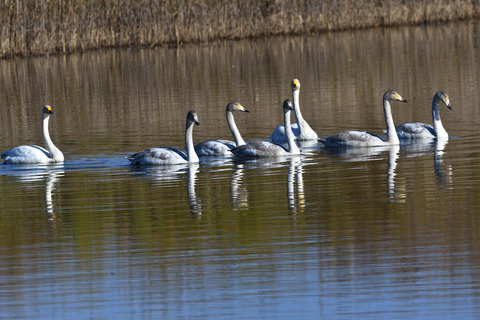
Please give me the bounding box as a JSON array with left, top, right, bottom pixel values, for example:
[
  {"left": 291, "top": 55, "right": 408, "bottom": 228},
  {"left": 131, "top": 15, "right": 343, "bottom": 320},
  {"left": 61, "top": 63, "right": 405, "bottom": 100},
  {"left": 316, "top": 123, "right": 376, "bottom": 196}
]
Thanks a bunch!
[{"left": 396, "top": 90, "right": 452, "bottom": 140}]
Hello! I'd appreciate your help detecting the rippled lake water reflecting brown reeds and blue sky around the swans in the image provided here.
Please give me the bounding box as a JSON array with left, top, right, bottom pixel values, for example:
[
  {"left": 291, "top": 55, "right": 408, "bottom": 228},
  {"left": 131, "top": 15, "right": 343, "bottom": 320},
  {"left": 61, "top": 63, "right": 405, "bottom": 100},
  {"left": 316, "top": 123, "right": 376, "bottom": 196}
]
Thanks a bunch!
[{"left": 0, "top": 22, "right": 480, "bottom": 319}]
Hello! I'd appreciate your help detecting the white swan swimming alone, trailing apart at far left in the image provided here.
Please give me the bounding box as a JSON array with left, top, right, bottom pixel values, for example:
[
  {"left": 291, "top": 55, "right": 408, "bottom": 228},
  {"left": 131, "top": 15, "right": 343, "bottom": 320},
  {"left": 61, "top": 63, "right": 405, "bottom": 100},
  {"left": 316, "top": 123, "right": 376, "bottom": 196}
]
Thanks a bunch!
[{"left": 1, "top": 105, "right": 64, "bottom": 164}]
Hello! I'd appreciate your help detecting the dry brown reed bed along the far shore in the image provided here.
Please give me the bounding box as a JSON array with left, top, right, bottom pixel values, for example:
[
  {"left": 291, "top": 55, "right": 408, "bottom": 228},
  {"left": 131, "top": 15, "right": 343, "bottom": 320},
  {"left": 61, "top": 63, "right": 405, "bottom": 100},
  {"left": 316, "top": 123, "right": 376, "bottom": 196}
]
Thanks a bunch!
[{"left": 0, "top": 0, "right": 480, "bottom": 58}]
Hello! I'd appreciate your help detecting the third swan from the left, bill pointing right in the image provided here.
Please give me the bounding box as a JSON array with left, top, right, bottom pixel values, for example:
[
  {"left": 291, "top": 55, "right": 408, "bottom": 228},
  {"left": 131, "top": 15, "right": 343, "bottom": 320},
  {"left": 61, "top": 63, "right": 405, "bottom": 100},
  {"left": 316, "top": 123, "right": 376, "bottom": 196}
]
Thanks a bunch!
[{"left": 195, "top": 101, "right": 250, "bottom": 157}]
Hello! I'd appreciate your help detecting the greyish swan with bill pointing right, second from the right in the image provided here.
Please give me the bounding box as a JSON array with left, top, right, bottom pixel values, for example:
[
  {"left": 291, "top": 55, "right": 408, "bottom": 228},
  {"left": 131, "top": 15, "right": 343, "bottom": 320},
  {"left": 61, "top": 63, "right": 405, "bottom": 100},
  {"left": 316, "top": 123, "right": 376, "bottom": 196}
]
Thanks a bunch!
[{"left": 320, "top": 90, "right": 407, "bottom": 147}]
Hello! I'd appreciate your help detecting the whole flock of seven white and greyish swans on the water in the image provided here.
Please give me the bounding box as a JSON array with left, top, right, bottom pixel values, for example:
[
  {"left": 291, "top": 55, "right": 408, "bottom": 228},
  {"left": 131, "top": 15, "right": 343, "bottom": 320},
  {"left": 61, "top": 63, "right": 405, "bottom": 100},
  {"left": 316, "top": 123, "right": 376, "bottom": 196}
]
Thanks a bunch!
[{"left": 1, "top": 79, "right": 452, "bottom": 165}]
